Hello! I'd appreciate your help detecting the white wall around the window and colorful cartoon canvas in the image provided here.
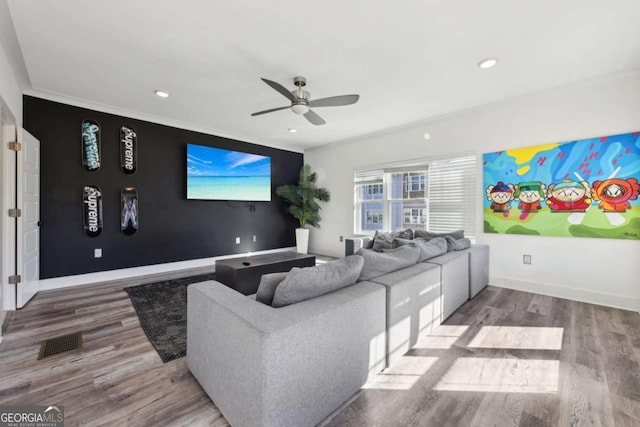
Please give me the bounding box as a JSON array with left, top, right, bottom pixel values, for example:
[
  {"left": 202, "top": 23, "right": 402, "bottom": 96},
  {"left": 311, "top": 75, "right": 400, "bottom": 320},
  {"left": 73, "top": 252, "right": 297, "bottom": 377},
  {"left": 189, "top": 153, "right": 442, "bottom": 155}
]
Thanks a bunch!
[{"left": 305, "top": 73, "right": 640, "bottom": 311}]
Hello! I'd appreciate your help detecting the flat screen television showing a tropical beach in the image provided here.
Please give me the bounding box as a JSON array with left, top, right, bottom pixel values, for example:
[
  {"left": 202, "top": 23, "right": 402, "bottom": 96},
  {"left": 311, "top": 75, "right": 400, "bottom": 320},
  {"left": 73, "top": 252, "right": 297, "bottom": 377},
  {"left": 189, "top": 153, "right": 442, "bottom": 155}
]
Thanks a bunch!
[{"left": 187, "top": 144, "right": 271, "bottom": 202}]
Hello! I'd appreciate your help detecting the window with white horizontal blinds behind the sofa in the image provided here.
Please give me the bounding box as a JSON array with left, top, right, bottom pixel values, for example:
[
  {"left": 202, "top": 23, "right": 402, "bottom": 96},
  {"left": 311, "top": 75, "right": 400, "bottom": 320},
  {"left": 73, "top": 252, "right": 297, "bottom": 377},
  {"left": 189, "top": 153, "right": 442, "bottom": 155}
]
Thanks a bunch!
[{"left": 354, "top": 156, "right": 476, "bottom": 237}]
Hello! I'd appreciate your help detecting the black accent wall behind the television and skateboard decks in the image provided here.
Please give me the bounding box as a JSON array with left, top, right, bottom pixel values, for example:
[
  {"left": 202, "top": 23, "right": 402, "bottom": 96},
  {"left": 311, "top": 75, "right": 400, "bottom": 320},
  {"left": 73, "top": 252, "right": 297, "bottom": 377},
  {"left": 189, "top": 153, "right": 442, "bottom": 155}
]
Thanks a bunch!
[{"left": 23, "top": 96, "right": 303, "bottom": 279}]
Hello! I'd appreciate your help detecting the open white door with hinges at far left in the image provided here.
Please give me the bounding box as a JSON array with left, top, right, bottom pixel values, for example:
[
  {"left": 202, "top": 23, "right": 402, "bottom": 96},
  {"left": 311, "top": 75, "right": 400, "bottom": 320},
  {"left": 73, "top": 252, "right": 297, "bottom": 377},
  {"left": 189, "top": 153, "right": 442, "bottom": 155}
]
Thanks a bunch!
[{"left": 16, "top": 130, "right": 40, "bottom": 308}]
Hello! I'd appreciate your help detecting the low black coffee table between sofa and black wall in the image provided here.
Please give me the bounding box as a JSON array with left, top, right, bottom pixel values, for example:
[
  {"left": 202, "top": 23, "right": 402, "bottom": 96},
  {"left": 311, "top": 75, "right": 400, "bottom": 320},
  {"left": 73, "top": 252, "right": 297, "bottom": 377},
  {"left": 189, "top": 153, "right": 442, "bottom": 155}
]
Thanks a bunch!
[{"left": 216, "top": 252, "right": 316, "bottom": 295}]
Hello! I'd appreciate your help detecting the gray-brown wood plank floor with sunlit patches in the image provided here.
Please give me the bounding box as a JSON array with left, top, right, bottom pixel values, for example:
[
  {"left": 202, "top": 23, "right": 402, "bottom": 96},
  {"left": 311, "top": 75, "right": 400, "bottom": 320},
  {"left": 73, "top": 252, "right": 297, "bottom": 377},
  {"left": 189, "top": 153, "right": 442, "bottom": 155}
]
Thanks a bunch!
[{"left": 0, "top": 280, "right": 640, "bottom": 427}]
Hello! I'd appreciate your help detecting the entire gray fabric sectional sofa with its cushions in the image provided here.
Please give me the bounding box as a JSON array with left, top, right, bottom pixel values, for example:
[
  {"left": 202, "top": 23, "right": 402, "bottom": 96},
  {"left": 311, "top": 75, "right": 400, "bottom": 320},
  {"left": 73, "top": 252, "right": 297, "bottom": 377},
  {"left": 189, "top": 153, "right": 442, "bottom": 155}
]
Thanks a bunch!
[{"left": 187, "top": 231, "right": 489, "bottom": 426}]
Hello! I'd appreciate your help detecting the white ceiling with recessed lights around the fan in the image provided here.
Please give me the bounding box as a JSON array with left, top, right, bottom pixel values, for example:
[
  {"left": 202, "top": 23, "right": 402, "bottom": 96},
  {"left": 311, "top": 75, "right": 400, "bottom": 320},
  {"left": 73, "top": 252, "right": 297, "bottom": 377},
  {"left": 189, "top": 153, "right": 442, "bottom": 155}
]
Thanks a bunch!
[{"left": 5, "top": 0, "right": 640, "bottom": 150}]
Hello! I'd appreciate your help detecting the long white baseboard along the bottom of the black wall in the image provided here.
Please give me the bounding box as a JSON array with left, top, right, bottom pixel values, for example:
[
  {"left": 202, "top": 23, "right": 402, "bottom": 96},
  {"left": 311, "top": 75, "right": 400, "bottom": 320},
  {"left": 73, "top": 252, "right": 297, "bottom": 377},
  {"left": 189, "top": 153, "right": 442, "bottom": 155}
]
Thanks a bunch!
[{"left": 38, "top": 247, "right": 296, "bottom": 291}]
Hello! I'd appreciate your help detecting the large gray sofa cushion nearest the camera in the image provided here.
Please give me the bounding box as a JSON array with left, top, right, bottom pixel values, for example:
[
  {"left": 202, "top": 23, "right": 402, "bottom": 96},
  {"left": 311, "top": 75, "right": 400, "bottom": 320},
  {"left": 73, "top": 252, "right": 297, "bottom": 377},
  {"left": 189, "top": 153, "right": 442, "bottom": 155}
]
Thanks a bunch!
[{"left": 271, "top": 254, "right": 366, "bottom": 307}]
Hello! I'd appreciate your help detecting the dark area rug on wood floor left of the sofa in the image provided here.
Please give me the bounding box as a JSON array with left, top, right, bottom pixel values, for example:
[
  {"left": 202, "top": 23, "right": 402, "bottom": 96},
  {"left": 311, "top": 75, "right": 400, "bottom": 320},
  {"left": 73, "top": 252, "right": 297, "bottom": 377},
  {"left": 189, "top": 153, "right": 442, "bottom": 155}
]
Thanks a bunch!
[{"left": 124, "top": 273, "right": 215, "bottom": 363}]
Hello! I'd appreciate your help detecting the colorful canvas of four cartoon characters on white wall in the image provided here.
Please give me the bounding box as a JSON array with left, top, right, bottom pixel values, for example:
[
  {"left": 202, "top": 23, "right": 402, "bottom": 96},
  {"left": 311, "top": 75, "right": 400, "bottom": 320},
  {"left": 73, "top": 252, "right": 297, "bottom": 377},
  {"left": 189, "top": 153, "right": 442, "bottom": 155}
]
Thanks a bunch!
[{"left": 483, "top": 132, "right": 640, "bottom": 240}]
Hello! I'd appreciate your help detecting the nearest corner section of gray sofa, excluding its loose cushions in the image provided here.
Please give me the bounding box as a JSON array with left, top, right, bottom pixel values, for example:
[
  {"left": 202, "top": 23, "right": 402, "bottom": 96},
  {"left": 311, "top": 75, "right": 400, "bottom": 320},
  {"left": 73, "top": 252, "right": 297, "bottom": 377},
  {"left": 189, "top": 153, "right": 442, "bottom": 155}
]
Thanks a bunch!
[{"left": 187, "top": 281, "right": 385, "bottom": 426}]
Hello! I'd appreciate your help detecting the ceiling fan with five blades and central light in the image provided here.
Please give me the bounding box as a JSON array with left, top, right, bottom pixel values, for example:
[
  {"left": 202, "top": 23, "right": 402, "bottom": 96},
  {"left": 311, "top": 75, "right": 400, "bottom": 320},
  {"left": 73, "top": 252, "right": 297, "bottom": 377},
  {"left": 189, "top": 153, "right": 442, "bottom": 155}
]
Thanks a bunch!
[{"left": 252, "top": 76, "right": 360, "bottom": 125}]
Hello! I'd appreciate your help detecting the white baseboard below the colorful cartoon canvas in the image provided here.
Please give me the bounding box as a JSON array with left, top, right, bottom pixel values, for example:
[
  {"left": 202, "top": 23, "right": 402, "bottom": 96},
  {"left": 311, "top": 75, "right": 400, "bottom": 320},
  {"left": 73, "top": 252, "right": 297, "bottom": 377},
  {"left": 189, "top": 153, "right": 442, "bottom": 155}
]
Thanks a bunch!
[{"left": 489, "top": 276, "right": 640, "bottom": 311}]
